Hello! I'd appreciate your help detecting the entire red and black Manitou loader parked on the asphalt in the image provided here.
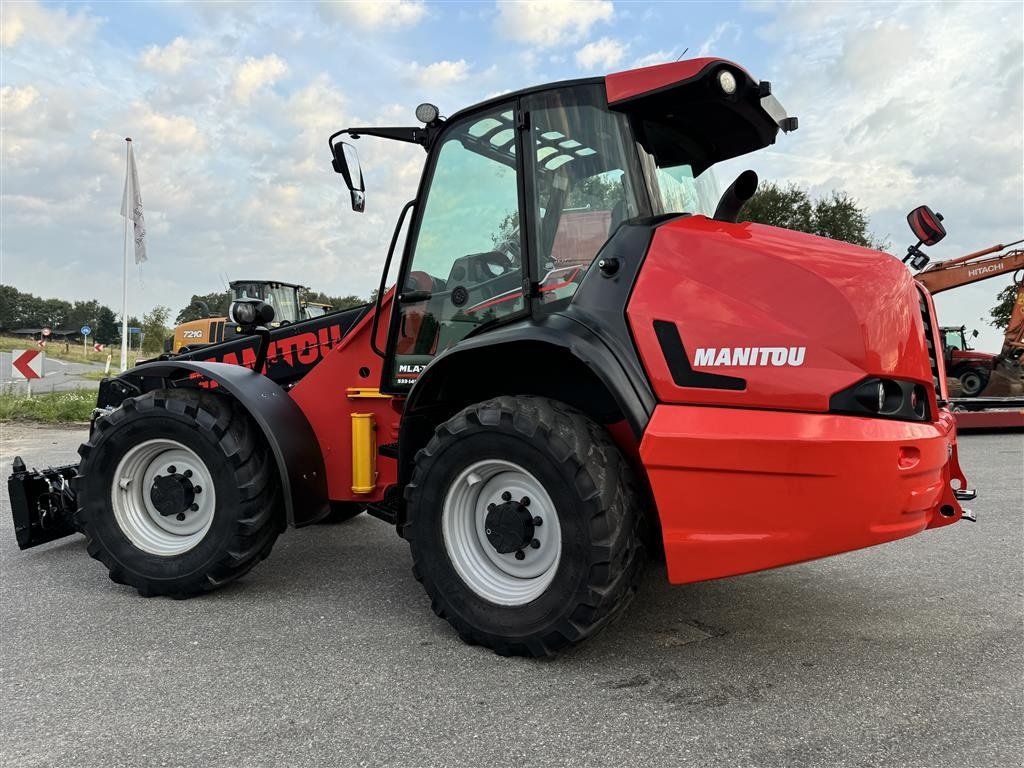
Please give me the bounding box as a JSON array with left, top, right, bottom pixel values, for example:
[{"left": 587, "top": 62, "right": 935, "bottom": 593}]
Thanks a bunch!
[{"left": 10, "top": 58, "right": 974, "bottom": 655}]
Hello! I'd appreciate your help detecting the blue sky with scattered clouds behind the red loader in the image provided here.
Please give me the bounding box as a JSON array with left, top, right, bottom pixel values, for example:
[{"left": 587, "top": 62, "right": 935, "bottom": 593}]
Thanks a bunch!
[{"left": 0, "top": 0, "right": 1024, "bottom": 349}]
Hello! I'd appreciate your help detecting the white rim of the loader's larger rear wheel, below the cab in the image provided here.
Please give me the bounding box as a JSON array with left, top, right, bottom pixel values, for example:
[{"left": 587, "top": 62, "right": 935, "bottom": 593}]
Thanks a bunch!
[{"left": 441, "top": 459, "right": 562, "bottom": 605}]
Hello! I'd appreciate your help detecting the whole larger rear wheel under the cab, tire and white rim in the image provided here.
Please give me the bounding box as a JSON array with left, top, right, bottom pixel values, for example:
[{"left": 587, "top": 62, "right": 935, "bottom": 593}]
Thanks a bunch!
[{"left": 403, "top": 397, "right": 643, "bottom": 656}]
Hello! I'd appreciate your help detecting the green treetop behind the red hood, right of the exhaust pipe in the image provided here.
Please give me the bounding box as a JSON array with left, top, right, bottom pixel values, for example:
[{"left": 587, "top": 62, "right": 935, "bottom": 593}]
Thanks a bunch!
[{"left": 740, "top": 181, "right": 889, "bottom": 251}]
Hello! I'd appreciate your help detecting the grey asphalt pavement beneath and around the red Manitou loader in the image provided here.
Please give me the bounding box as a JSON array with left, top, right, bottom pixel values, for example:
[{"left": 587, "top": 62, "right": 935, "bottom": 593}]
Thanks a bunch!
[{"left": 0, "top": 425, "right": 1024, "bottom": 768}]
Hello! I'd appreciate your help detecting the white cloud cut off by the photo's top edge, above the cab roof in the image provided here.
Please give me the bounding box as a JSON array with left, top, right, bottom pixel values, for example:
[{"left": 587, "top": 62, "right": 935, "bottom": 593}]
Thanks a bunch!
[{"left": 498, "top": 0, "right": 614, "bottom": 48}]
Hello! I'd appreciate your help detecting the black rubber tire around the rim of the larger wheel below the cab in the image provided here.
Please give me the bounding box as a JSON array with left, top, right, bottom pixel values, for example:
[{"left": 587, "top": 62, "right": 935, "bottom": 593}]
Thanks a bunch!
[{"left": 402, "top": 396, "right": 644, "bottom": 656}]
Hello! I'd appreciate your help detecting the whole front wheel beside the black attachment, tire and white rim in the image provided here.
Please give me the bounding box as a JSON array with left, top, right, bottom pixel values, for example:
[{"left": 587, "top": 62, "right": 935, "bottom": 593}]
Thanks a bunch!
[{"left": 76, "top": 389, "right": 282, "bottom": 597}]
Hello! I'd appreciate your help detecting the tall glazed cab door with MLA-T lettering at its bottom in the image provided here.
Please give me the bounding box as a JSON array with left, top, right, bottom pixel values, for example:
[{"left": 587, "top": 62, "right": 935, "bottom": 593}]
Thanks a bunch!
[{"left": 382, "top": 102, "right": 527, "bottom": 392}]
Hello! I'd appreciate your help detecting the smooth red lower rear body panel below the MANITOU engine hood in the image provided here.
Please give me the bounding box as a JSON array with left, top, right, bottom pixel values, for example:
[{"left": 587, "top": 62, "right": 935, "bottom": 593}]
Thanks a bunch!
[{"left": 640, "top": 406, "right": 966, "bottom": 584}]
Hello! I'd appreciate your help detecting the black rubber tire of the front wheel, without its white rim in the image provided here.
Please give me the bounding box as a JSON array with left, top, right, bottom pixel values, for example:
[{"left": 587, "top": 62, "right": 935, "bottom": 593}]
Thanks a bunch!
[{"left": 75, "top": 389, "right": 284, "bottom": 598}]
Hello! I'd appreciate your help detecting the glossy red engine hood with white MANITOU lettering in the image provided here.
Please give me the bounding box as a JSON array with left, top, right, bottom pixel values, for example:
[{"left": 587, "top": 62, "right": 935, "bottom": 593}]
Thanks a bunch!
[{"left": 627, "top": 216, "right": 932, "bottom": 411}]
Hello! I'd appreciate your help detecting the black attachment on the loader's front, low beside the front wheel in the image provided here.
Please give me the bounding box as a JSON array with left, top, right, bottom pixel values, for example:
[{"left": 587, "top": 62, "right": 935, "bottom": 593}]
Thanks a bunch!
[{"left": 7, "top": 456, "right": 78, "bottom": 549}]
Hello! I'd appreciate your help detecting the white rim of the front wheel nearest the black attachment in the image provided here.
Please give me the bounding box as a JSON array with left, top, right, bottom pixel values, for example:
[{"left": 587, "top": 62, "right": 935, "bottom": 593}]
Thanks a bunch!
[{"left": 111, "top": 438, "right": 217, "bottom": 557}]
